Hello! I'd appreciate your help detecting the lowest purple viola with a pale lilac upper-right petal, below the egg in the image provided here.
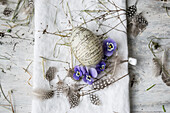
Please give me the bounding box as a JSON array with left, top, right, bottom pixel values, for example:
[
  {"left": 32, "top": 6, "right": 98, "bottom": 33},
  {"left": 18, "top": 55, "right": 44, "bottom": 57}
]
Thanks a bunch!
[{"left": 83, "top": 68, "right": 98, "bottom": 85}]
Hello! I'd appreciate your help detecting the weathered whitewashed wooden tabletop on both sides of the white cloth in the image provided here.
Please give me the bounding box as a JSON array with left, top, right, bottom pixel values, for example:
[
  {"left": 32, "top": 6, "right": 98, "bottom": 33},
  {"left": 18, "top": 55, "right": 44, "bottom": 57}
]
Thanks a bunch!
[{"left": 0, "top": 0, "right": 170, "bottom": 113}]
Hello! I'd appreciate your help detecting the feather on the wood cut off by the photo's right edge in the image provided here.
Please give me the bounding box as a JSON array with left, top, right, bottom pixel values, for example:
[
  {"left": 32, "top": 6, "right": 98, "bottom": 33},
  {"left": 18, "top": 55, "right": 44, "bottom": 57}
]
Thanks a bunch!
[{"left": 161, "top": 50, "right": 170, "bottom": 86}]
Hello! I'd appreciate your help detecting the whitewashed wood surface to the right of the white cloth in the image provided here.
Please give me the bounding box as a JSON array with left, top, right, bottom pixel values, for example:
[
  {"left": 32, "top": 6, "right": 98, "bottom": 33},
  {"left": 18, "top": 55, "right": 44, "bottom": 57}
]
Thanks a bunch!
[{"left": 128, "top": 0, "right": 170, "bottom": 113}]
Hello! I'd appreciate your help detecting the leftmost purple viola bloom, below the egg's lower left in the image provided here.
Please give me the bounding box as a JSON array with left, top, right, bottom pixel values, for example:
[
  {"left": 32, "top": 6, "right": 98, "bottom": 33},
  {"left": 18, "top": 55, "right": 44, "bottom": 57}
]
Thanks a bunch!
[{"left": 73, "top": 66, "right": 83, "bottom": 80}]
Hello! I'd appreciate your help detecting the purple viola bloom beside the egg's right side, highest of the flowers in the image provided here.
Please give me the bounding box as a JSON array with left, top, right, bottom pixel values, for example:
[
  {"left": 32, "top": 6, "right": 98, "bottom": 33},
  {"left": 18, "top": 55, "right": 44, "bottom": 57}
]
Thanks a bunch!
[{"left": 103, "top": 38, "right": 117, "bottom": 56}]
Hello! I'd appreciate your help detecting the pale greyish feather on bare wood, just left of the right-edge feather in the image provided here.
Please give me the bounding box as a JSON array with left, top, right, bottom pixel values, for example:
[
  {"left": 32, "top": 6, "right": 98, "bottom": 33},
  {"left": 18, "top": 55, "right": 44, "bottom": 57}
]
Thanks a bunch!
[{"left": 152, "top": 58, "right": 162, "bottom": 77}]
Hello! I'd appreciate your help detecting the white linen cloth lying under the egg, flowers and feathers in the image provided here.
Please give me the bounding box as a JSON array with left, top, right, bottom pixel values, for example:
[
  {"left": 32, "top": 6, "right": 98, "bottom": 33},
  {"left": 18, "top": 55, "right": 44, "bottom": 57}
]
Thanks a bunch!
[{"left": 32, "top": 0, "right": 130, "bottom": 113}]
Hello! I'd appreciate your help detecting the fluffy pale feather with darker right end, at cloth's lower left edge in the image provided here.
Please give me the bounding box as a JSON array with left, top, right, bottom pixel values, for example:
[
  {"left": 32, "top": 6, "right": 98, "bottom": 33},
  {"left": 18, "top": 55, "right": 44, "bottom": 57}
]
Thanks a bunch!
[{"left": 33, "top": 89, "right": 54, "bottom": 100}]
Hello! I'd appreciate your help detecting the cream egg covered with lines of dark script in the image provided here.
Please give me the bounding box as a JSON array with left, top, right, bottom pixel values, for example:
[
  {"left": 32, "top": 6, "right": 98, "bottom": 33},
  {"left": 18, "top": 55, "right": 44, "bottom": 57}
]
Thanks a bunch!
[{"left": 70, "top": 27, "right": 103, "bottom": 66}]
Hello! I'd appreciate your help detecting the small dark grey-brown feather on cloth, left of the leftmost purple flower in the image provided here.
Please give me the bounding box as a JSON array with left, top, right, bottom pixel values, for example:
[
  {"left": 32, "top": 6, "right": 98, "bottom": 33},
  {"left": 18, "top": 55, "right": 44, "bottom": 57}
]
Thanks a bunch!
[{"left": 45, "top": 67, "right": 57, "bottom": 82}]
